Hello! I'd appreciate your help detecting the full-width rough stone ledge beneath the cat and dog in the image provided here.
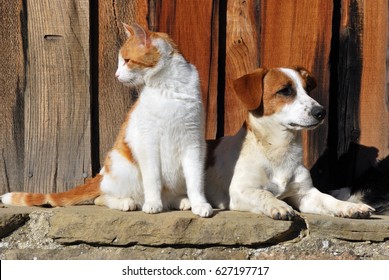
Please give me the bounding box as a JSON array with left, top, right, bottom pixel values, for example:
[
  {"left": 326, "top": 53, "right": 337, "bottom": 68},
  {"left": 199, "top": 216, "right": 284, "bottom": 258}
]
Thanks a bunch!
[{"left": 0, "top": 205, "right": 389, "bottom": 259}]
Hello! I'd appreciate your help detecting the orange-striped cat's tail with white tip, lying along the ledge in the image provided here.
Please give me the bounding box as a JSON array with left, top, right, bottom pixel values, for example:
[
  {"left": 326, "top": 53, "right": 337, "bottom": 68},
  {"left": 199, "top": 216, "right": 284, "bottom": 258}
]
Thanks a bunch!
[{"left": 0, "top": 174, "right": 102, "bottom": 207}]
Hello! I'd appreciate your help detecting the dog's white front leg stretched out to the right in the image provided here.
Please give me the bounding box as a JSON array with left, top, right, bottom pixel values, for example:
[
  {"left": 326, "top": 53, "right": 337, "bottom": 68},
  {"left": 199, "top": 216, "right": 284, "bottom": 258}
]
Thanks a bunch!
[{"left": 286, "top": 168, "right": 374, "bottom": 218}]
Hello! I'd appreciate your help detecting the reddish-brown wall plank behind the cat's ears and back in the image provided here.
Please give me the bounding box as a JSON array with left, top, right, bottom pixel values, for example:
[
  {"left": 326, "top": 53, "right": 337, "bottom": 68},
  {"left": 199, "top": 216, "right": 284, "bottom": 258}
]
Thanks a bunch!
[{"left": 150, "top": 0, "right": 219, "bottom": 139}]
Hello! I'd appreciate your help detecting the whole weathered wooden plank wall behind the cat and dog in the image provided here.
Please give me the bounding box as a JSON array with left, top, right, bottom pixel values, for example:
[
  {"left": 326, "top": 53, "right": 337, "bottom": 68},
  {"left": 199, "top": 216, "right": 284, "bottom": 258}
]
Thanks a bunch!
[{"left": 0, "top": 0, "right": 389, "bottom": 193}]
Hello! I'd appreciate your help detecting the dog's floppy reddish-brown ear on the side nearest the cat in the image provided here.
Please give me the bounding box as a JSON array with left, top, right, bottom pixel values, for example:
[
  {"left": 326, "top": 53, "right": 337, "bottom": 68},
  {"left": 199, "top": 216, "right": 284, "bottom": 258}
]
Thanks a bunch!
[{"left": 234, "top": 68, "right": 268, "bottom": 110}]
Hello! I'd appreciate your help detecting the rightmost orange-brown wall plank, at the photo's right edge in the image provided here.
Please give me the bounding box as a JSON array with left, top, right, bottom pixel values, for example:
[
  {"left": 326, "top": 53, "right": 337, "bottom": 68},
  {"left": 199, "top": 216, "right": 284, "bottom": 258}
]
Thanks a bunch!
[{"left": 357, "top": 0, "right": 389, "bottom": 164}]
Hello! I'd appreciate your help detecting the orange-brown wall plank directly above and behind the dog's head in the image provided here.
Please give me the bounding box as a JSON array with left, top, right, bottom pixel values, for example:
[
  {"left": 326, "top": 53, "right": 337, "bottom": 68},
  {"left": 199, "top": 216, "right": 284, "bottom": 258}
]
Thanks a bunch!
[{"left": 260, "top": 0, "right": 333, "bottom": 167}]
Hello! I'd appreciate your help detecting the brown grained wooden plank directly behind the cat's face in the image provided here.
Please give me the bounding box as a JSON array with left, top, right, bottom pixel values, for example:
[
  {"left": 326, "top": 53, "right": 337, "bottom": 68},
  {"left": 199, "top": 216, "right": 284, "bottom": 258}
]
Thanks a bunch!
[{"left": 96, "top": 0, "right": 148, "bottom": 167}]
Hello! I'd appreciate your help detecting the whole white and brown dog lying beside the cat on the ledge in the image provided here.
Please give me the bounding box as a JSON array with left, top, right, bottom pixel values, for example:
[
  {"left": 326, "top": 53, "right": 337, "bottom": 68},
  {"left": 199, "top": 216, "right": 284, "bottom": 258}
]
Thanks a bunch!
[{"left": 206, "top": 67, "right": 374, "bottom": 220}]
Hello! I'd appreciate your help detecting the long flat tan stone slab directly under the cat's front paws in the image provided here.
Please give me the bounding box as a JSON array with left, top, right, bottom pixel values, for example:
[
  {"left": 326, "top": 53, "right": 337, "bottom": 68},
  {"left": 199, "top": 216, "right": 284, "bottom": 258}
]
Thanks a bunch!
[{"left": 47, "top": 206, "right": 306, "bottom": 246}]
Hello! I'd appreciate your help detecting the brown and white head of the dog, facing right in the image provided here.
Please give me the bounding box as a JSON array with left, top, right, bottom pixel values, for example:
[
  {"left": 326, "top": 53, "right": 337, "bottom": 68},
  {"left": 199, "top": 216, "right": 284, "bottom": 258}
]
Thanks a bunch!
[{"left": 234, "top": 66, "right": 326, "bottom": 130}]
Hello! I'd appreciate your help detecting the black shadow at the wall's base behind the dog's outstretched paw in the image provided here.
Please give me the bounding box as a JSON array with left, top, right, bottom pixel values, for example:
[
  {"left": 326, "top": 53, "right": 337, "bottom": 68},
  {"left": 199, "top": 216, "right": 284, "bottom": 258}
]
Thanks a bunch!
[{"left": 311, "top": 143, "right": 389, "bottom": 214}]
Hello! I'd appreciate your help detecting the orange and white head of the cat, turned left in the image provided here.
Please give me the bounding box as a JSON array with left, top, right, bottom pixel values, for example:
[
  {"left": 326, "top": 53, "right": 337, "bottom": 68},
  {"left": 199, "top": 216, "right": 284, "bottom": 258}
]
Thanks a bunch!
[{"left": 115, "top": 23, "right": 177, "bottom": 85}]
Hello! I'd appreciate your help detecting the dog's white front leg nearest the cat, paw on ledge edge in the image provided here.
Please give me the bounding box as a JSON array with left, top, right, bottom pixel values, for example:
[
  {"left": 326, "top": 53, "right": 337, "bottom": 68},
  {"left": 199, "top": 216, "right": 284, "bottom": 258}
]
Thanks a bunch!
[{"left": 230, "top": 186, "right": 295, "bottom": 220}]
